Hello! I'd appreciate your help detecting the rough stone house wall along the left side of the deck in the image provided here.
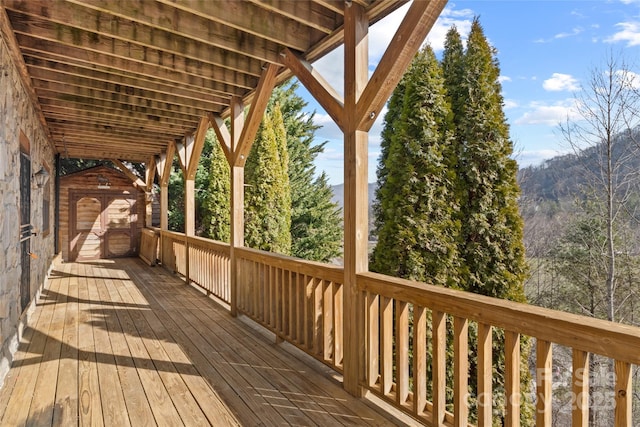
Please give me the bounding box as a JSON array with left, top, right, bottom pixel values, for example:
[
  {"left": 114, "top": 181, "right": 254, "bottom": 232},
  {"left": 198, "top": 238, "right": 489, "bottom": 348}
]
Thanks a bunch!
[{"left": 0, "top": 33, "right": 55, "bottom": 386}]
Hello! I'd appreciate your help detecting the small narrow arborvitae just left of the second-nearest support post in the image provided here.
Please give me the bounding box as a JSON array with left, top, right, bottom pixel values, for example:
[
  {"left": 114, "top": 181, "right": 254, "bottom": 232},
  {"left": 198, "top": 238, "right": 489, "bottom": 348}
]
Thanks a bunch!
[{"left": 202, "top": 129, "right": 231, "bottom": 242}]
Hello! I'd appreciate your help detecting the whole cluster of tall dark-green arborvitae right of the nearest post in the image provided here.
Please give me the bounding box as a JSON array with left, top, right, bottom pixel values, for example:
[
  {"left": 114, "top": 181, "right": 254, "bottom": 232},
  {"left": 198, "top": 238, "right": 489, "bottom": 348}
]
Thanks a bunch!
[{"left": 370, "top": 19, "right": 533, "bottom": 425}]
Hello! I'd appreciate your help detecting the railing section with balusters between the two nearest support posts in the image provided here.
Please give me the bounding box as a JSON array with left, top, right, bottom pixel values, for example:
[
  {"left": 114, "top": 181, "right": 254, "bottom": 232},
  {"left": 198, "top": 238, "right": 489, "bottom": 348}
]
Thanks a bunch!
[{"left": 236, "top": 248, "right": 343, "bottom": 372}]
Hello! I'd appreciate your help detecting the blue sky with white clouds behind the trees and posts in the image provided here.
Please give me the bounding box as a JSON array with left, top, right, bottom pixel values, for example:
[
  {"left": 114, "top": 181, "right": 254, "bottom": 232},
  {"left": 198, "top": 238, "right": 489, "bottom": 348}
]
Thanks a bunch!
[{"left": 299, "top": 0, "right": 640, "bottom": 185}]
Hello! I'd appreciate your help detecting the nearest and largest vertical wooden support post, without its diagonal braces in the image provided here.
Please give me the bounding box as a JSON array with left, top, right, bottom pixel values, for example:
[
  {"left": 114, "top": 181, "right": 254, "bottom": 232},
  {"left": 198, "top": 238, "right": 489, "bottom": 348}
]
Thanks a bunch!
[{"left": 343, "top": 3, "right": 369, "bottom": 396}]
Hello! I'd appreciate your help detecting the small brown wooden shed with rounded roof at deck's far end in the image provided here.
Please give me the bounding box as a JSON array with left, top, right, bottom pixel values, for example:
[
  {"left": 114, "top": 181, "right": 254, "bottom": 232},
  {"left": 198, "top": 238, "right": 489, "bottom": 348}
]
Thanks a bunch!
[{"left": 59, "top": 166, "right": 145, "bottom": 261}]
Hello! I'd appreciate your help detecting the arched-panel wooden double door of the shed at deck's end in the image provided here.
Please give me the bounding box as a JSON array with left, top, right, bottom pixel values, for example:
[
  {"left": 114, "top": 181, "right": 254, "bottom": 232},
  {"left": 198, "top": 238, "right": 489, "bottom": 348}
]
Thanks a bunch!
[{"left": 69, "top": 194, "right": 137, "bottom": 261}]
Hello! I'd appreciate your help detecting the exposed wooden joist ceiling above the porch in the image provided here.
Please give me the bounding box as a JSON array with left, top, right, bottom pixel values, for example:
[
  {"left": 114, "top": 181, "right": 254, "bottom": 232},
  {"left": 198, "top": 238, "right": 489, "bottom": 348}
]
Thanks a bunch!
[{"left": 0, "top": 0, "right": 406, "bottom": 161}]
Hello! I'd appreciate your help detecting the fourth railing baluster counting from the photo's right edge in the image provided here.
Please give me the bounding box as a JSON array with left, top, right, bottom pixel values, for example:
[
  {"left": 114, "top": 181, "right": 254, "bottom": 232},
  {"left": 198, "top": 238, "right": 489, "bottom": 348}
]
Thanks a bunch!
[{"left": 504, "top": 331, "right": 520, "bottom": 427}]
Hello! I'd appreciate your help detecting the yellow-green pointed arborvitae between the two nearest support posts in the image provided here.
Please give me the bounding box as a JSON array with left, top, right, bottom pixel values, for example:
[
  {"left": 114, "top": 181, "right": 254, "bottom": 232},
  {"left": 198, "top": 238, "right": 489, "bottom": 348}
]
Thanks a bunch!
[{"left": 245, "top": 105, "right": 291, "bottom": 255}]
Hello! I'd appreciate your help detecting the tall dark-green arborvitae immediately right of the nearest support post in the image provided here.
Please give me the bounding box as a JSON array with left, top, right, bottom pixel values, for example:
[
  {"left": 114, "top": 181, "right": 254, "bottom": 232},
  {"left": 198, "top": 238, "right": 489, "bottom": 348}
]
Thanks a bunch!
[{"left": 371, "top": 47, "right": 458, "bottom": 286}]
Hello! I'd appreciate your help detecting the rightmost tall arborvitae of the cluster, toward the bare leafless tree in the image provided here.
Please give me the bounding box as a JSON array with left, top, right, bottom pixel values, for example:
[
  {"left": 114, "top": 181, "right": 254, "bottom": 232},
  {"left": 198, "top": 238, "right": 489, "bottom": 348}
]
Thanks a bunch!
[{"left": 445, "top": 19, "right": 533, "bottom": 425}]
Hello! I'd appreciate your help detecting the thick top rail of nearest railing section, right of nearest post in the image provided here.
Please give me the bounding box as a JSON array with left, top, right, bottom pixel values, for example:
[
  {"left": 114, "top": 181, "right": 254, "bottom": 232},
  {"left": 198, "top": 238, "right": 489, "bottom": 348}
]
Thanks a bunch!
[{"left": 357, "top": 273, "right": 640, "bottom": 365}]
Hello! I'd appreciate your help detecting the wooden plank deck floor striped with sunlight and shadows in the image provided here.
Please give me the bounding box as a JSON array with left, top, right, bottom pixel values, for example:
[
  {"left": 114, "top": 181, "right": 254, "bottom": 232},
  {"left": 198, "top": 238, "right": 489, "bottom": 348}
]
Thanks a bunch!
[{"left": 0, "top": 259, "right": 408, "bottom": 427}]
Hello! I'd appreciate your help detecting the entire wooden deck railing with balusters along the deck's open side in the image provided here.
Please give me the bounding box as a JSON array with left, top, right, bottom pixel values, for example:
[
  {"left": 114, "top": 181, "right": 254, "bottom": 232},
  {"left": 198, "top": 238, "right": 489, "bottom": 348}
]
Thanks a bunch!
[{"left": 156, "top": 231, "right": 640, "bottom": 426}]
